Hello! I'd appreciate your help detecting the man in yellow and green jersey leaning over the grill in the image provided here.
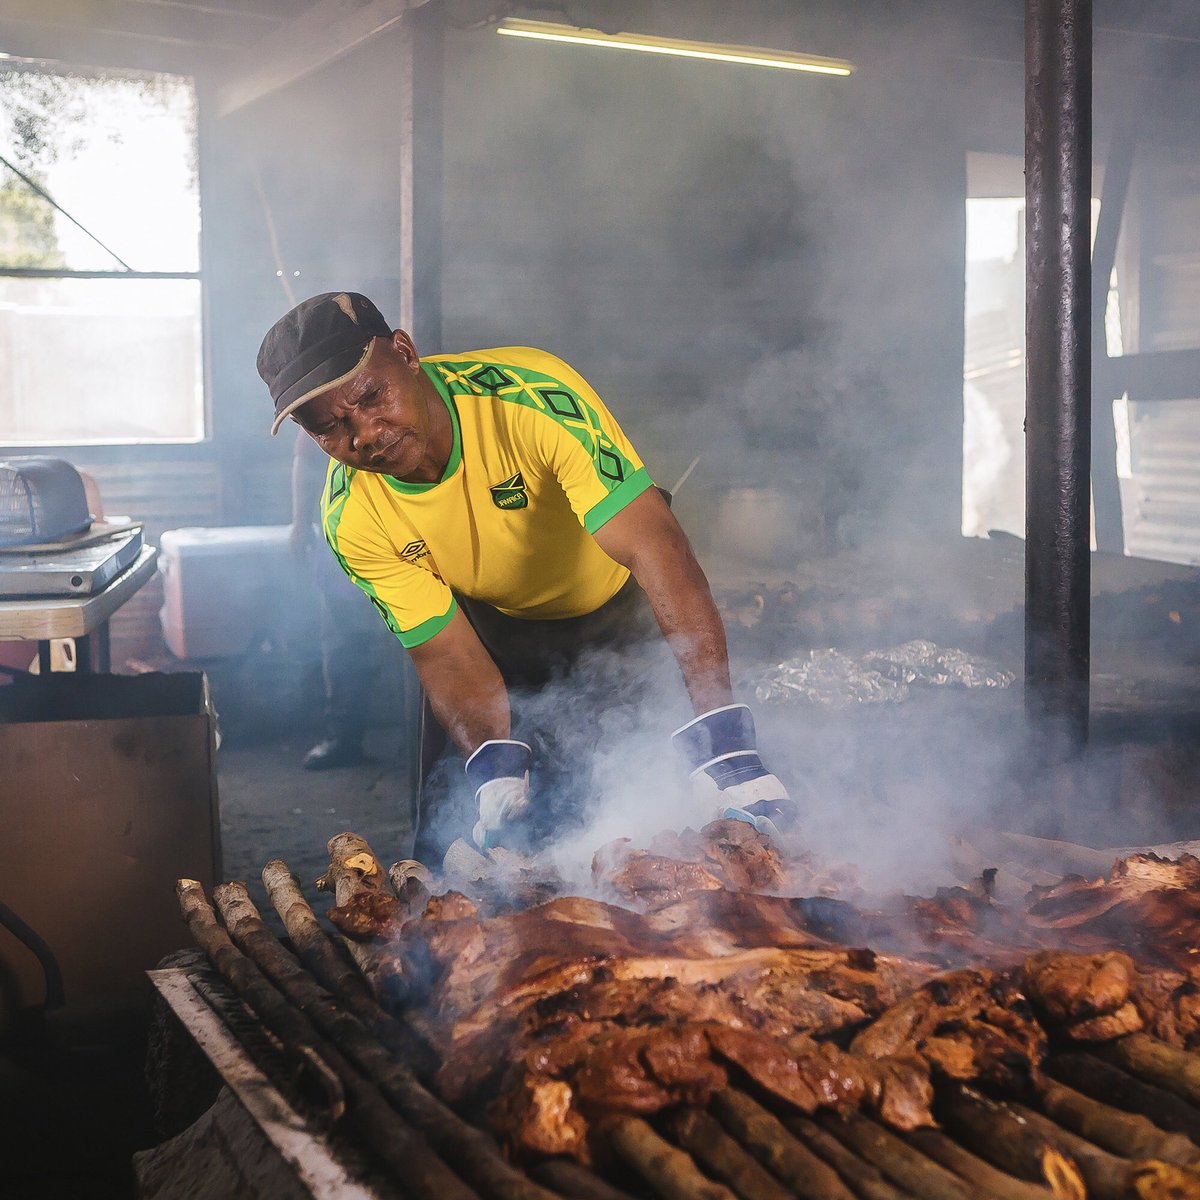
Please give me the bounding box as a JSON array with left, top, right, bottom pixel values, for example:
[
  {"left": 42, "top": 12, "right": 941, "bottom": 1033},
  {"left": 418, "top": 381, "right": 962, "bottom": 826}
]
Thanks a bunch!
[{"left": 258, "top": 292, "right": 797, "bottom": 857}]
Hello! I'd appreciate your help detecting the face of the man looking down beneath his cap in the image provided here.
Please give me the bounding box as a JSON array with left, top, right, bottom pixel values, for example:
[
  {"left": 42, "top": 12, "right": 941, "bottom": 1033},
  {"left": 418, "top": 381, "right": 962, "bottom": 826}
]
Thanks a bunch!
[{"left": 295, "top": 330, "right": 437, "bottom": 479}]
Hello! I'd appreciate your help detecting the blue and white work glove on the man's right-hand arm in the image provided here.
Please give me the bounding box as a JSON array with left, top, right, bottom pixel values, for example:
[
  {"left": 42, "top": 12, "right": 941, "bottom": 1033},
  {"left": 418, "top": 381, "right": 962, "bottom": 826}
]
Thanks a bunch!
[{"left": 671, "top": 704, "right": 799, "bottom": 838}]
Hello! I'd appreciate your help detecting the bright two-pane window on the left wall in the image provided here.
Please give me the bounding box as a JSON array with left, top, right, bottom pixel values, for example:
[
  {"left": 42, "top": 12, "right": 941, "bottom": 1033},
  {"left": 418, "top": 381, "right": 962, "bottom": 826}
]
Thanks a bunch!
[{"left": 0, "top": 59, "right": 205, "bottom": 445}]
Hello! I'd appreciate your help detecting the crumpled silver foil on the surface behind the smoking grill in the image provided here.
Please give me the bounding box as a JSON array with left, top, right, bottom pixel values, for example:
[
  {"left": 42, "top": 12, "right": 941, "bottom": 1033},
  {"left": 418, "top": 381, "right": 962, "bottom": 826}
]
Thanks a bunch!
[{"left": 754, "top": 638, "right": 1015, "bottom": 708}]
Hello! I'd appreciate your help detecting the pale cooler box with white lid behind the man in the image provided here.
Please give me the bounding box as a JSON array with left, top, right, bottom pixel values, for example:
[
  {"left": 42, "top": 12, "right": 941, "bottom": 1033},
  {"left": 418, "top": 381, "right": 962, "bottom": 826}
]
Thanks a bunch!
[{"left": 158, "top": 526, "right": 316, "bottom": 659}]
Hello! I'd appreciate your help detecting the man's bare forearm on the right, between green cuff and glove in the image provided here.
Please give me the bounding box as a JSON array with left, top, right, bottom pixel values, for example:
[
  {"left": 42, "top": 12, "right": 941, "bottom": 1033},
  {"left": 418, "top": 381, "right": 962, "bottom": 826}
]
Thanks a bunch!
[{"left": 595, "top": 487, "right": 733, "bottom": 714}]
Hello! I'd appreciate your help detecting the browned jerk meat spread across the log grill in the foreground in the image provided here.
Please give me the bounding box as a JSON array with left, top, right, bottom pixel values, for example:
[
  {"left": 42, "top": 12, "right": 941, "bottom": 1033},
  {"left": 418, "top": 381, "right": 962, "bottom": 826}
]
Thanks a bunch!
[{"left": 314, "top": 821, "right": 1200, "bottom": 1162}]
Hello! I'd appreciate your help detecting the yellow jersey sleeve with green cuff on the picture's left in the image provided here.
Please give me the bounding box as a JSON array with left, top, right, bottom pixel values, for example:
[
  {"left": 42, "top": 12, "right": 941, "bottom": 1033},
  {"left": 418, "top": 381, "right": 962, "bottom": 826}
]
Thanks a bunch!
[{"left": 320, "top": 463, "right": 457, "bottom": 649}]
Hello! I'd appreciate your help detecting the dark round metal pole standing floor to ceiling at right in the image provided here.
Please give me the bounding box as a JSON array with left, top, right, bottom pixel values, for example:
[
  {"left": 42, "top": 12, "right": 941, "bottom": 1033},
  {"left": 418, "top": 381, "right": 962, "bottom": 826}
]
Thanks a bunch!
[{"left": 1025, "top": 0, "right": 1092, "bottom": 754}]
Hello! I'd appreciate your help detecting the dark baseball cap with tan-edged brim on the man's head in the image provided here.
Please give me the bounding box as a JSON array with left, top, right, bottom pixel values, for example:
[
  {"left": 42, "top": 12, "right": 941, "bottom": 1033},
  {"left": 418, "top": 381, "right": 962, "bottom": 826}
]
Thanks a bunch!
[{"left": 258, "top": 292, "right": 391, "bottom": 437}]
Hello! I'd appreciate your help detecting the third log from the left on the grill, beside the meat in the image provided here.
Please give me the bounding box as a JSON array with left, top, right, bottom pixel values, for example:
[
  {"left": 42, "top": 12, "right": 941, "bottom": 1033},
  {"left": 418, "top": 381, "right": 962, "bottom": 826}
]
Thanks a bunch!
[{"left": 263, "top": 858, "right": 439, "bottom": 1078}]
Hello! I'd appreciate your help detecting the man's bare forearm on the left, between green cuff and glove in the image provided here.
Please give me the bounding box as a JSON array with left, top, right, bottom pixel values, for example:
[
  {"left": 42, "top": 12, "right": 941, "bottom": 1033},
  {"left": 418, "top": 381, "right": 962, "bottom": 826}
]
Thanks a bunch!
[{"left": 408, "top": 611, "right": 510, "bottom": 757}]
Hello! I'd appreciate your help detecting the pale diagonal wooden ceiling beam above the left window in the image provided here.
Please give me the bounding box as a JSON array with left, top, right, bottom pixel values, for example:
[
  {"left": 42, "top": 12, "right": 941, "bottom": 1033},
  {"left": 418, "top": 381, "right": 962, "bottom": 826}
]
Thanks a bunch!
[{"left": 216, "top": 0, "right": 427, "bottom": 116}]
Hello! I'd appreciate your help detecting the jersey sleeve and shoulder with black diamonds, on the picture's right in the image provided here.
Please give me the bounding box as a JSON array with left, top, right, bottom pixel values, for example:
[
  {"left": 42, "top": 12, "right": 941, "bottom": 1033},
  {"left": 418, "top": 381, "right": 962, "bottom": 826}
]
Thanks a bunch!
[{"left": 438, "top": 352, "right": 654, "bottom": 533}]
